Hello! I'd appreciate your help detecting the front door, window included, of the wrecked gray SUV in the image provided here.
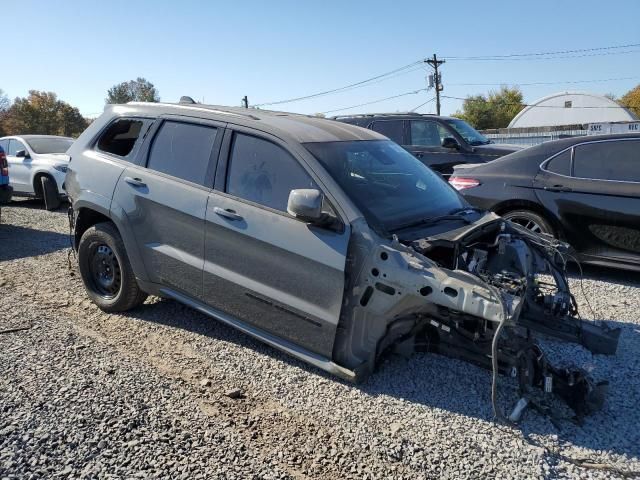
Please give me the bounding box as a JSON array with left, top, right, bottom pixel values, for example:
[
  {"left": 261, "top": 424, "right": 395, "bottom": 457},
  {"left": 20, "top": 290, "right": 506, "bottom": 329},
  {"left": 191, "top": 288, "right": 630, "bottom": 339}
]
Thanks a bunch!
[{"left": 204, "top": 127, "right": 349, "bottom": 358}]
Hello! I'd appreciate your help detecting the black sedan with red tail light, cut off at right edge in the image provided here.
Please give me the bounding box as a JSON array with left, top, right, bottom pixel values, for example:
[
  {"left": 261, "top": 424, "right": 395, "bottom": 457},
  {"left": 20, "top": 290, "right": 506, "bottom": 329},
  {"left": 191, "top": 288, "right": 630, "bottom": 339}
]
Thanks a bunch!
[{"left": 449, "top": 135, "right": 640, "bottom": 271}]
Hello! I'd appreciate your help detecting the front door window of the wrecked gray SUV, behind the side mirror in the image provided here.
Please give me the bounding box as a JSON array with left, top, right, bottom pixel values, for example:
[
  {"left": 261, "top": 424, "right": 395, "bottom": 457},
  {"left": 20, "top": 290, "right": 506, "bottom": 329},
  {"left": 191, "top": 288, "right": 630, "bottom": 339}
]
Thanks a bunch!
[{"left": 227, "top": 133, "right": 318, "bottom": 212}]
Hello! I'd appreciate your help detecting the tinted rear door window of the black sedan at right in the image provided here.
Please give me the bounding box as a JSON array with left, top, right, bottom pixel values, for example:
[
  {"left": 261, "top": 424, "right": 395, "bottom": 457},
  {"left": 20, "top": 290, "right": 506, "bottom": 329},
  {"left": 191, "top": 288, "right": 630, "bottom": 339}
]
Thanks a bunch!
[{"left": 573, "top": 140, "right": 640, "bottom": 182}]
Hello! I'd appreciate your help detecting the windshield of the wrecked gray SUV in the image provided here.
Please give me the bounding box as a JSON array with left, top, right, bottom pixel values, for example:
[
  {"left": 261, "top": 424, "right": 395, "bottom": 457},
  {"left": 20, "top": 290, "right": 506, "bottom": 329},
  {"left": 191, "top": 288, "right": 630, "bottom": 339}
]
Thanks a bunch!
[{"left": 304, "top": 140, "right": 467, "bottom": 232}]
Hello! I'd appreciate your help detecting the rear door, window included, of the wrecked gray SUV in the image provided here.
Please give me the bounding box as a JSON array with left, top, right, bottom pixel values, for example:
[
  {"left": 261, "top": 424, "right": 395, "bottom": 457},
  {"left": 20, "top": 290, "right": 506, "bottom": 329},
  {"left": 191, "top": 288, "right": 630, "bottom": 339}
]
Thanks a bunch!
[{"left": 114, "top": 116, "right": 224, "bottom": 299}]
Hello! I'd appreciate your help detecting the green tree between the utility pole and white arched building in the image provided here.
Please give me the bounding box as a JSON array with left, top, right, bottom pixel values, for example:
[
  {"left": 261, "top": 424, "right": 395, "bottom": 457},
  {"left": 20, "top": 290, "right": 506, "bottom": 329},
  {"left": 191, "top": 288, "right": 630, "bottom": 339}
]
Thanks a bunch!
[{"left": 454, "top": 86, "right": 524, "bottom": 130}]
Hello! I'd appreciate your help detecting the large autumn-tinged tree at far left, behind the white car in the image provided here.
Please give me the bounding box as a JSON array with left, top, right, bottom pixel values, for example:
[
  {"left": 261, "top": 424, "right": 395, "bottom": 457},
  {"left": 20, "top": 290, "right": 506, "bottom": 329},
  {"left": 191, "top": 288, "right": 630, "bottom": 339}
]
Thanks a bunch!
[{"left": 2, "top": 90, "right": 87, "bottom": 137}]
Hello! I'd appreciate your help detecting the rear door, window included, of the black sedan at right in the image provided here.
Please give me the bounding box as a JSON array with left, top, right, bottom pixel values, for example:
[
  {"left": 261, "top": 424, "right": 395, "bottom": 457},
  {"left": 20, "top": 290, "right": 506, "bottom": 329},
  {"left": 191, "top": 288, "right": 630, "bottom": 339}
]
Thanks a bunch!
[{"left": 535, "top": 139, "right": 640, "bottom": 264}]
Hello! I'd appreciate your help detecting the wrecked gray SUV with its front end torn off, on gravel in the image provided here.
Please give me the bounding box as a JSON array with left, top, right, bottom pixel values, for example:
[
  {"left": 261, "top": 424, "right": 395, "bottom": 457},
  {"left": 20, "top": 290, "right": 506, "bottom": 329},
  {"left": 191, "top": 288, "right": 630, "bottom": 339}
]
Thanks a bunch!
[{"left": 66, "top": 103, "right": 619, "bottom": 416}]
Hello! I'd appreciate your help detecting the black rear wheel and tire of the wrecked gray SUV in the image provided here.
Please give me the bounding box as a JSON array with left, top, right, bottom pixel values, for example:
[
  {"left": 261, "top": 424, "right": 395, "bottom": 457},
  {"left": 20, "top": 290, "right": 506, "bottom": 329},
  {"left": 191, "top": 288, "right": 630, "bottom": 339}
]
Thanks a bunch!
[{"left": 78, "top": 222, "right": 147, "bottom": 312}]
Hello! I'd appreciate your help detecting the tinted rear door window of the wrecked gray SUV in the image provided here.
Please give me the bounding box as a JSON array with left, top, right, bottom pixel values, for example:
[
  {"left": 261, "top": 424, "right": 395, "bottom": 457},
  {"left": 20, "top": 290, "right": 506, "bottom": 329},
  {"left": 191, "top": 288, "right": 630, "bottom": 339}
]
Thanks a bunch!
[{"left": 147, "top": 122, "right": 218, "bottom": 186}]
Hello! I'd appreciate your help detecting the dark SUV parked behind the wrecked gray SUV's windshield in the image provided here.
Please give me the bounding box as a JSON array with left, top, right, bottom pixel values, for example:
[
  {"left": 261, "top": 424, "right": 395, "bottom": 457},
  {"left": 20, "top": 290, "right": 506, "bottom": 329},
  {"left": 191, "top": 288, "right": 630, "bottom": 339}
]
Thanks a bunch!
[{"left": 333, "top": 113, "right": 522, "bottom": 175}]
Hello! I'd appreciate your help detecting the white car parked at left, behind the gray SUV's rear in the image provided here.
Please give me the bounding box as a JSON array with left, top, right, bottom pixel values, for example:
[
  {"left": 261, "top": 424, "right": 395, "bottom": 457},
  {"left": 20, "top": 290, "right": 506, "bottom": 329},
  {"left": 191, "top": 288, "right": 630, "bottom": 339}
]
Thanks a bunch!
[{"left": 0, "top": 135, "right": 73, "bottom": 210}]
